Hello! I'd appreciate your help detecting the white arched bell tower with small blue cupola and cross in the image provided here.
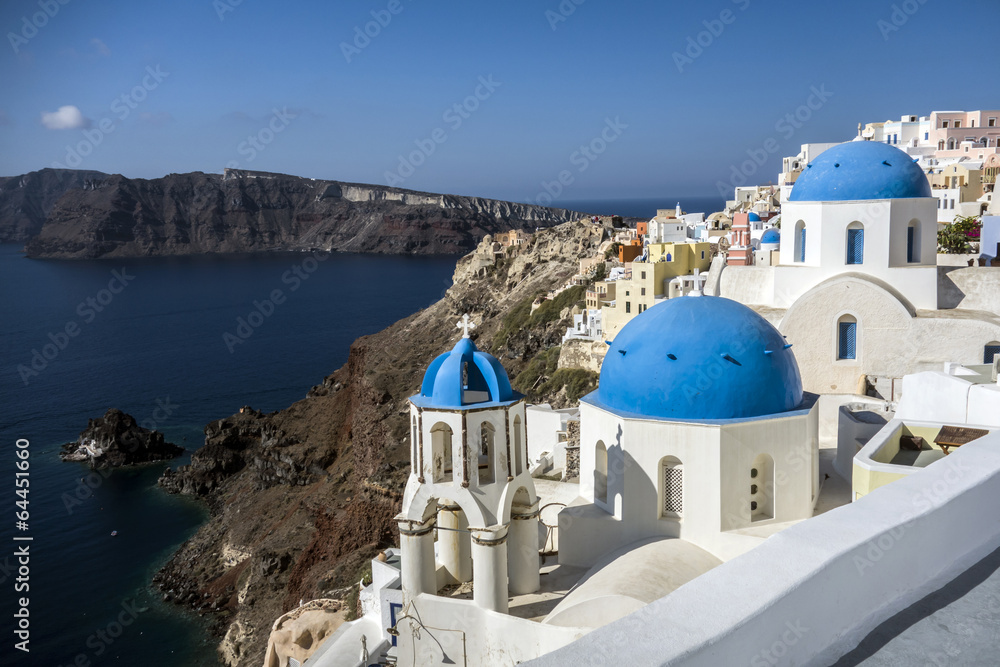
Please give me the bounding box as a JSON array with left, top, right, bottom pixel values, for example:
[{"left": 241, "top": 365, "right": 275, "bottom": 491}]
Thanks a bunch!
[{"left": 397, "top": 324, "right": 539, "bottom": 612}]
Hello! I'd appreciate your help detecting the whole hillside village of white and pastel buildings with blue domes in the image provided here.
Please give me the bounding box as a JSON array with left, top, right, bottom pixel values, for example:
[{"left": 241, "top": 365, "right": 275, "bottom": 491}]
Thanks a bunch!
[{"left": 244, "top": 111, "right": 1000, "bottom": 667}]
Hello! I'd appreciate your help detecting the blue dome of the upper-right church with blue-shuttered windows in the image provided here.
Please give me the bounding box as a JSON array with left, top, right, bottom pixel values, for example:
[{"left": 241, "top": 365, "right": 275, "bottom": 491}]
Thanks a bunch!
[{"left": 788, "top": 141, "right": 934, "bottom": 201}]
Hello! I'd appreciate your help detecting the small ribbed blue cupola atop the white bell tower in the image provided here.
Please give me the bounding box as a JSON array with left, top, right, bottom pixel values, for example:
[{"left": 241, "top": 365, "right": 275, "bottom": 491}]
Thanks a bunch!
[{"left": 418, "top": 338, "right": 522, "bottom": 409}]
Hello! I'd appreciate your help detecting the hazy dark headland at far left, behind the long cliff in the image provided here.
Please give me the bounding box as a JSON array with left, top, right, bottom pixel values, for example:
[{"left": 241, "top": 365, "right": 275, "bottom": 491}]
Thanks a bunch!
[{"left": 0, "top": 169, "right": 108, "bottom": 243}]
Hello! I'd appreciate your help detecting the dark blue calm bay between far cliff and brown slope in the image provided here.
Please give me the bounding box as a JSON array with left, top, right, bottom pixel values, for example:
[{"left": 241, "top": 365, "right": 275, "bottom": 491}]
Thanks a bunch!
[{"left": 0, "top": 245, "right": 455, "bottom": 667}]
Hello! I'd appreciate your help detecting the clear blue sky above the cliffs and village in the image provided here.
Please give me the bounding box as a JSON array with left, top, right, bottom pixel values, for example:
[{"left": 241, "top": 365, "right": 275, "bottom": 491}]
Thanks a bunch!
[{"left": 0, "top": 0, "right": 1000, "bottom": 201}]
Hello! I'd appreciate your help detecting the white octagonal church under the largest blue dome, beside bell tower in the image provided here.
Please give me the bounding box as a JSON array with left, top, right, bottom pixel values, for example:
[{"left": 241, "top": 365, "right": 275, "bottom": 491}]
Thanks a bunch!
[{"left": 559, "top": 296, "right": 818, "bottom": 566}]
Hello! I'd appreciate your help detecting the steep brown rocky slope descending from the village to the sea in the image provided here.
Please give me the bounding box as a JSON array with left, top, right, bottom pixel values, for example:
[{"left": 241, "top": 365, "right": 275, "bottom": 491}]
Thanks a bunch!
[{"left": 156, "top": 222, "right": 609, "bottom": 667}]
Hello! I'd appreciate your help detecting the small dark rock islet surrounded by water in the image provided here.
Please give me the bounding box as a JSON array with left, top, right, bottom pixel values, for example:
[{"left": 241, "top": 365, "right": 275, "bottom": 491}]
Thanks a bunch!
[{"left": 59, "top": 408, "right": 184, "bottom": 468}]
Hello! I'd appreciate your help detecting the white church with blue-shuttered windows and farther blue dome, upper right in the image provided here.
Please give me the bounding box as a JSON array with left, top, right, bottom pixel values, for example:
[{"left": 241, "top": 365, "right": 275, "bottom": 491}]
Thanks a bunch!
[{"left": 707, "top": 142, "right": 1000, "bottom": 400}]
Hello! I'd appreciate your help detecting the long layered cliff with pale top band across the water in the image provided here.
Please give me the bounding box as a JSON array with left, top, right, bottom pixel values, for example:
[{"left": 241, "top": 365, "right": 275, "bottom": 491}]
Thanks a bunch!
[{"left": 26, "top": 169, "right": 583, "bottom": 258}]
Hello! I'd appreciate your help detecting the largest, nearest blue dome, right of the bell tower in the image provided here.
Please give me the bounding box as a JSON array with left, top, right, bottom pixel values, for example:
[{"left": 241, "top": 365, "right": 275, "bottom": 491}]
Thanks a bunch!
[{"left": 584, "top": 296, "right": 803, "bottom": 420}]
